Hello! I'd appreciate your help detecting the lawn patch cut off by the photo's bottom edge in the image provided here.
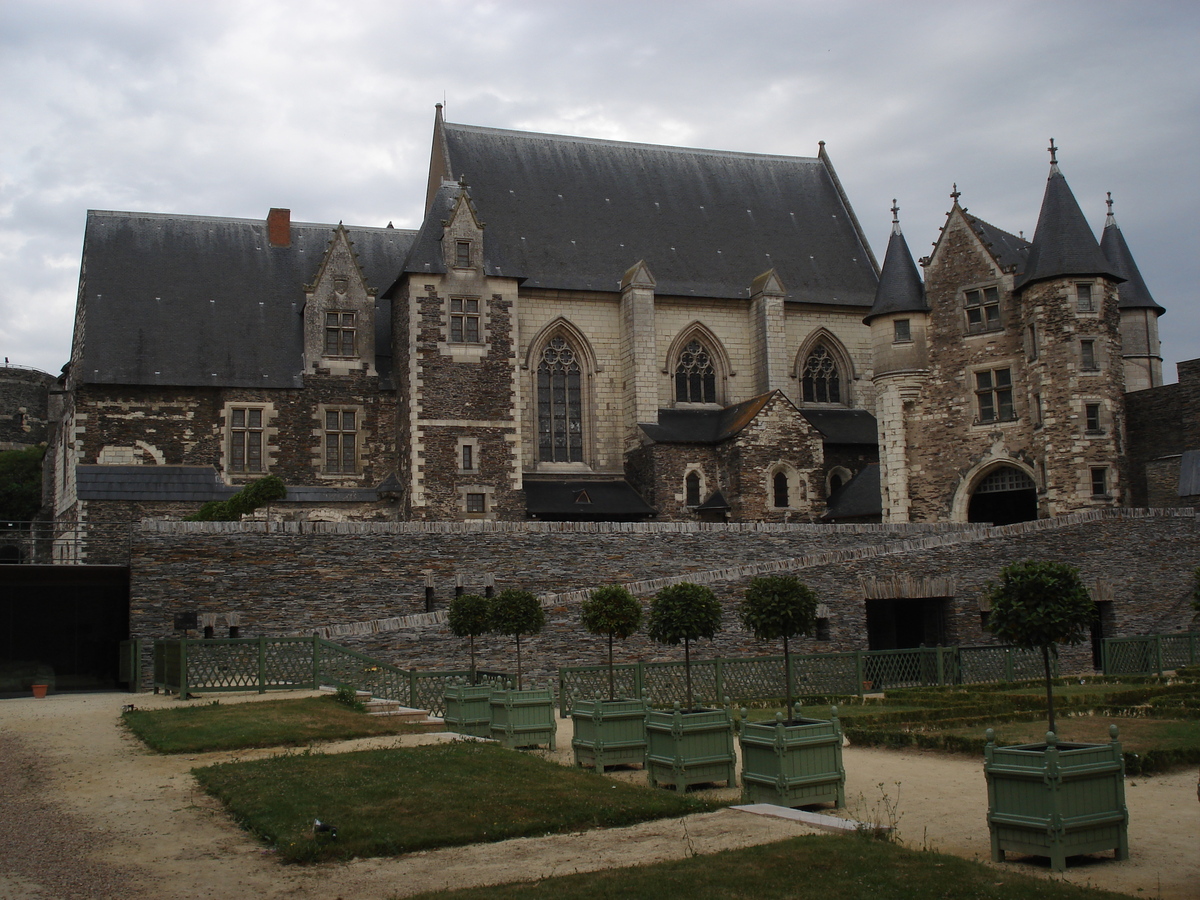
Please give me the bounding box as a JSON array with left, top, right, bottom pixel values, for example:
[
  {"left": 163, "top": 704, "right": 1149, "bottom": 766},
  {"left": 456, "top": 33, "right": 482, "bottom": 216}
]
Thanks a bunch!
[{"left": 414, "top": 835, "right": 1128, "bottom": 900}]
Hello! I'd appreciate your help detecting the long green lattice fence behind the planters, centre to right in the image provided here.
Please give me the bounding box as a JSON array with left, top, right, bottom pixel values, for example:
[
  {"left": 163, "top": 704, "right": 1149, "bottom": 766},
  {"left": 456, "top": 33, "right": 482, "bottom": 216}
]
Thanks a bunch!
[{"left": 558, "top": 647, "right": 1042, "bottom": 716}]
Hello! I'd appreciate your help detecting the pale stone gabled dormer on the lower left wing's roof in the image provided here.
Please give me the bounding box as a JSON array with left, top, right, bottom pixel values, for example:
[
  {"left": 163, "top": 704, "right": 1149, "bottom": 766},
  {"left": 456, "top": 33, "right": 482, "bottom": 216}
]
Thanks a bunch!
[{"left": 304, "top": 229, "right": 376, "bottom": 376}]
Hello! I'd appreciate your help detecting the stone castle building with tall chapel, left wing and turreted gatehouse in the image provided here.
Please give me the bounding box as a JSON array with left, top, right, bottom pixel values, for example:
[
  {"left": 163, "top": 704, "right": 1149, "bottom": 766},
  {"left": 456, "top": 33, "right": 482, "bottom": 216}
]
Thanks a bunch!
[{"left": 48, "top": 106, "right": 1163, "bottom": 540}]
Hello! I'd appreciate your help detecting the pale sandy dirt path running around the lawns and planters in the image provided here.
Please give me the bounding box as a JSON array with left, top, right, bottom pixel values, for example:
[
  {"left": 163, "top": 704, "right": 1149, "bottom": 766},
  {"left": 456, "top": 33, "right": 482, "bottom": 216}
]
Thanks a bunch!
[{"left": 0, "top": 694, "right": 1200, "bottom": 900}]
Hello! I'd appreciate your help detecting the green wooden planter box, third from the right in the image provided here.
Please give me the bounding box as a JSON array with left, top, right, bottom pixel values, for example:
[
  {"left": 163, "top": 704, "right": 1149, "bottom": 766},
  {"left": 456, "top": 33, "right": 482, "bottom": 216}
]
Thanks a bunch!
[{"left": 646, "top": 703, "right": 737, "bottom": 791}]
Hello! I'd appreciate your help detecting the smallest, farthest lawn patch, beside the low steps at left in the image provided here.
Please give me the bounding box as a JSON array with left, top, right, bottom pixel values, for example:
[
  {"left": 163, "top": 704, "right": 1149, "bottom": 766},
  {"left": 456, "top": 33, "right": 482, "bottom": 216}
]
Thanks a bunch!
[{"left": 121, "top": 697, "right": 431, "bottom": 754}]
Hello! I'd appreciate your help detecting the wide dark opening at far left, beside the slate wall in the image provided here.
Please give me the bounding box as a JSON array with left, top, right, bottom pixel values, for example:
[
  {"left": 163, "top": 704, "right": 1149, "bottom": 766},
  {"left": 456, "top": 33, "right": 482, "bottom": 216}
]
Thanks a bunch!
[{"left": 0, "top": 565, "right": 130, "bottom": 694}]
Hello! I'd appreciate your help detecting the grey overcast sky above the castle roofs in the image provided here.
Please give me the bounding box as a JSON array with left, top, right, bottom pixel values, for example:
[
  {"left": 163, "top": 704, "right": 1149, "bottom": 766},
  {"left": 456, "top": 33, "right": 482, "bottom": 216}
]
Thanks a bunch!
[{"left": 0, "top": 0, "right": 1200, "bottom": 382}]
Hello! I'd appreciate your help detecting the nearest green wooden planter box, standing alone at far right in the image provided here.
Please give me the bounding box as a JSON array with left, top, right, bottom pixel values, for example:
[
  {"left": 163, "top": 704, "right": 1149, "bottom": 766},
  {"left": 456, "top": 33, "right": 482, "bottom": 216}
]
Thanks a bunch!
[{"left": 984, "top": 725, "right": 1129, "bottom": 872}]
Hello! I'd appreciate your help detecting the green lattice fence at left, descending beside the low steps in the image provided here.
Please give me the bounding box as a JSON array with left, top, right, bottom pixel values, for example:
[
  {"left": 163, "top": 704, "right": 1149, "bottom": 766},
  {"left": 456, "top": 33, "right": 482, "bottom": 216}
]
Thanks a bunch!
[{"left": 150, "top": 635, "right": 511, "bottom": 715}]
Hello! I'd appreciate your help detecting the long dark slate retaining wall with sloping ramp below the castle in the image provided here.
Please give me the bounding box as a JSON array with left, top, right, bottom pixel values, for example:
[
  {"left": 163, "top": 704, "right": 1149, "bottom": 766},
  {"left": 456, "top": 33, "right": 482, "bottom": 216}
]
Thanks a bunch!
[{"left": 131, "top": 510, "right": 1200, "bottom": 680}]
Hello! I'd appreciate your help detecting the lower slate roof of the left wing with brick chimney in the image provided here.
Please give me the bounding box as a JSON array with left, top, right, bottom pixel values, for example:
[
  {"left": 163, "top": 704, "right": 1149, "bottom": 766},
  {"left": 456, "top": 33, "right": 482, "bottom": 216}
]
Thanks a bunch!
[{"left": 76, "top": 210, "right": 415, "bottom": 388}]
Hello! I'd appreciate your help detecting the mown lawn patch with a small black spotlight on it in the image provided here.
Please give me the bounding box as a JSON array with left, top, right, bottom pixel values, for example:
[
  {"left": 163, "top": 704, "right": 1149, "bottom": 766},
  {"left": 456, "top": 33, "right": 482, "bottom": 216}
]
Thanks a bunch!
[{"left": 193, "top": 742, "right": 722, "bottom": 863}]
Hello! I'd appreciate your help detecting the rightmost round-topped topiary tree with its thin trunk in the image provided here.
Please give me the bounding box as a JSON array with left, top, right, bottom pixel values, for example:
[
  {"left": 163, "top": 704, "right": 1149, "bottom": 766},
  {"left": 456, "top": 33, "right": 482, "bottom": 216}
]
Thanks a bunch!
[{"left": 985, "top": 560, "right": 1096, "bottom": 731}]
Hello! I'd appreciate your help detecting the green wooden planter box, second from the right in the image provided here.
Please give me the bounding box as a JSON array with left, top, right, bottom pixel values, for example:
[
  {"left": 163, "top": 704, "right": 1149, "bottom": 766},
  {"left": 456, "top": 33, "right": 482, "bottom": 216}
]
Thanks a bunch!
[{"left": 740, "top": 707, "right": 846, "bottom": 806}]
